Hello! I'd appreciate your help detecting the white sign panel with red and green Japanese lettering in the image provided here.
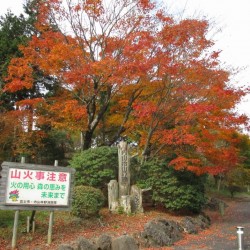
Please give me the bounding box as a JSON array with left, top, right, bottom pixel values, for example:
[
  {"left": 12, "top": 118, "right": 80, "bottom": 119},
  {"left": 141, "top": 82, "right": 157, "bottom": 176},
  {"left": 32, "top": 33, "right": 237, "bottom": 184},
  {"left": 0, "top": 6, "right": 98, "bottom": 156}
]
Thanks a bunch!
[{"left": 6, "top": 168, "right": 70, "bottom": 206}]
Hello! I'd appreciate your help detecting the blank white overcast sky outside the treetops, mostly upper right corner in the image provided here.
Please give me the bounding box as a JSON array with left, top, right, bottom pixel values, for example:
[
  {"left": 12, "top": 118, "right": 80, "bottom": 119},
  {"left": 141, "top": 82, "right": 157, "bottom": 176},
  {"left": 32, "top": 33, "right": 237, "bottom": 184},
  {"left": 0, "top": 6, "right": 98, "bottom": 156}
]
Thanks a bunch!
[{"left": 0, "top": 0, "right": 250, "bottom": 117}]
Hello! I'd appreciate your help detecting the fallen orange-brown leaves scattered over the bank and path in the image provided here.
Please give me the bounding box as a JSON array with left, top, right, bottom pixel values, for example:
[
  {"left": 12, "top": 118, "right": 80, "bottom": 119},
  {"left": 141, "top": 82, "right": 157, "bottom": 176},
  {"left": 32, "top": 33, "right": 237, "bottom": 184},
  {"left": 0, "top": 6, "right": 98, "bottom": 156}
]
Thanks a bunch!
[{"left": 0, "top": 197, "right": 247, "bottom": 250}]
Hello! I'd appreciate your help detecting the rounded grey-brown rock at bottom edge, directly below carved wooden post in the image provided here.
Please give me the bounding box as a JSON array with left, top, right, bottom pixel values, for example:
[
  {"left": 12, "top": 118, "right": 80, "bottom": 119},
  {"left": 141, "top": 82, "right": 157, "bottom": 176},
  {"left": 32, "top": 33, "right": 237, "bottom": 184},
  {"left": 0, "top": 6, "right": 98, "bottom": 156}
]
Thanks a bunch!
[{"left": 112, "top": 235, "right": 139, "bottom": 250}]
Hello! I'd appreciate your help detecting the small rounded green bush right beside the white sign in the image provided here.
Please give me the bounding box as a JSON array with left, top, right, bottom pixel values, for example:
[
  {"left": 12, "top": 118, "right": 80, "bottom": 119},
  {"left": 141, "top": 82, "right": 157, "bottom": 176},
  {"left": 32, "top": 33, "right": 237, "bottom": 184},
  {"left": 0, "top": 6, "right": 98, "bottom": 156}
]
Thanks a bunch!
[{"left": 71, "top": 186, "right": 105, "bottom": 218}]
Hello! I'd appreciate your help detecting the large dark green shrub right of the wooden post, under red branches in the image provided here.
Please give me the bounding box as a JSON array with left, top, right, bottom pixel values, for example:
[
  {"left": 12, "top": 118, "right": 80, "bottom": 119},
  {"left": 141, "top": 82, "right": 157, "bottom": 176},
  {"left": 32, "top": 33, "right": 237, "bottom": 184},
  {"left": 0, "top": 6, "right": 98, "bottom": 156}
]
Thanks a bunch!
[{"left": 140, "top": 161, "right": 206, "bottom": 213}]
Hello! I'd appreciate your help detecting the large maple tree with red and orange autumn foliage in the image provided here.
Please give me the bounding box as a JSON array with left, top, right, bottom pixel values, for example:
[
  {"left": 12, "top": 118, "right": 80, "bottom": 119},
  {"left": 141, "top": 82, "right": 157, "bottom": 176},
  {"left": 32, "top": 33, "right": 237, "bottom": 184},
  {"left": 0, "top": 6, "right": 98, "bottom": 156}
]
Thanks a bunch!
[{"left": 2, "top": 0, "right": 246, "bottom": 175}]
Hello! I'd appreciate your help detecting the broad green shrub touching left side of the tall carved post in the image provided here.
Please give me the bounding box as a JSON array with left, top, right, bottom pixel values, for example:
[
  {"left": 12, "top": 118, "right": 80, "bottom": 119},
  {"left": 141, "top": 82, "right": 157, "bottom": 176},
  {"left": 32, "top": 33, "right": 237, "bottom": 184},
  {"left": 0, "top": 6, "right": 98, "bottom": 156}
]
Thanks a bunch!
[{"left": 69, "top": 146, "right": 118, "bottom": 190}]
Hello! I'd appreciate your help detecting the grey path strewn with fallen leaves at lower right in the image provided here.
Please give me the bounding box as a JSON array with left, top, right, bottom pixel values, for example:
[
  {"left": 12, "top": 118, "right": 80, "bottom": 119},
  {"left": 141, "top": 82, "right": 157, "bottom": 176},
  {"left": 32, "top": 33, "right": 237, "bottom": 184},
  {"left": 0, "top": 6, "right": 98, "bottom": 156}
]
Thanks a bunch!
[{"left": 171, "top": 197, "right": 250, "bottom": 250}]
